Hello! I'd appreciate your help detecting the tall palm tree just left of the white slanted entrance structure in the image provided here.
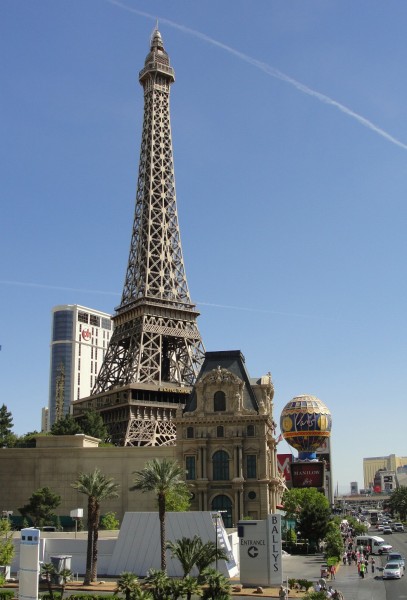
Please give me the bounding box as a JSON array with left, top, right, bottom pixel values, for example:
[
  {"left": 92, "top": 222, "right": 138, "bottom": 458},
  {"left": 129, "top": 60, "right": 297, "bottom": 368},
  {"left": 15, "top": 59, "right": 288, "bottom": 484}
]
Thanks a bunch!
[{"left": 71, "top": 468, "right": 119, "bottom": 585}]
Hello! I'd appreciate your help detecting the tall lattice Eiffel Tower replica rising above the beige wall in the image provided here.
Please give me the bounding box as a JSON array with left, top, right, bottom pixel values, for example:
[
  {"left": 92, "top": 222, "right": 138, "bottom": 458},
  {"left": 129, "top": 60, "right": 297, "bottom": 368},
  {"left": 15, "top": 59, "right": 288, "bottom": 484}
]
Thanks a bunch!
[{"left": 73, "top": 28, "right": 204, "bottom": 446}]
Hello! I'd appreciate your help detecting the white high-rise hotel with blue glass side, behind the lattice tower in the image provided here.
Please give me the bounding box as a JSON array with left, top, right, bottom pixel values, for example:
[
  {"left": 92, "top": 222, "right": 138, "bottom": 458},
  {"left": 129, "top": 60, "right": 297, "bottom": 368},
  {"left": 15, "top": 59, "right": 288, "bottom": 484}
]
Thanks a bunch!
[{"left": 48, "top": 304, "right": 113, "bottom": 427}]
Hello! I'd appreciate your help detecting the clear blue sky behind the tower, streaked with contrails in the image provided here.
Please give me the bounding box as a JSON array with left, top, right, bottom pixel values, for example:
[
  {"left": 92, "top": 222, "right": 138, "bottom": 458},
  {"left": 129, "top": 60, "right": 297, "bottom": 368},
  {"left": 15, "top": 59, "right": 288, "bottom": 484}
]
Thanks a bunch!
[{"left": 0, "top": 0, "right": 407, "bottom": 492}]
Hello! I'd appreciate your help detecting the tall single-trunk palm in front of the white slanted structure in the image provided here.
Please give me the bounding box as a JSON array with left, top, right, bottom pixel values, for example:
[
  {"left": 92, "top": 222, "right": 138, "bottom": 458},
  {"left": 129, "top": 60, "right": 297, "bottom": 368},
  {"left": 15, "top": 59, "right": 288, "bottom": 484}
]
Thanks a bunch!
[{"left": 130, "top": 458, "right": 187, "bottom": 571}]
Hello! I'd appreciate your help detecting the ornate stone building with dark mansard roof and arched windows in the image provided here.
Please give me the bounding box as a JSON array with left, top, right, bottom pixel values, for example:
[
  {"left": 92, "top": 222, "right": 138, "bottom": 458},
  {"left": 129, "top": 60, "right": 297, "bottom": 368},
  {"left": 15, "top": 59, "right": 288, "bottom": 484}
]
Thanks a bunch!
[{"left": 176, "top": 351, "right": 285, "bottom": 527}]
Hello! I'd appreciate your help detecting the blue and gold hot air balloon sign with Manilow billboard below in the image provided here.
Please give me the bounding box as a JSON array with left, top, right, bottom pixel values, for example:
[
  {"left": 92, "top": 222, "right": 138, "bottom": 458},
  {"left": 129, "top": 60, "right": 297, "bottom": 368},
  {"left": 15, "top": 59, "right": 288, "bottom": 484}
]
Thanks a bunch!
[{"left": 280, "top": 395, "right": 332, "bottom": 488}]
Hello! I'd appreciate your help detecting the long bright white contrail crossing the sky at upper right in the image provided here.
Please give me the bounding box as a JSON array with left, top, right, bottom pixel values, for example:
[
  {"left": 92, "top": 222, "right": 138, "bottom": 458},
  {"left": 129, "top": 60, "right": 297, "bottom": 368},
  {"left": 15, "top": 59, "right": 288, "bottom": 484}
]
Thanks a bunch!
[{"left": 106, "top": 0, "right": 407, "bottom": 150}]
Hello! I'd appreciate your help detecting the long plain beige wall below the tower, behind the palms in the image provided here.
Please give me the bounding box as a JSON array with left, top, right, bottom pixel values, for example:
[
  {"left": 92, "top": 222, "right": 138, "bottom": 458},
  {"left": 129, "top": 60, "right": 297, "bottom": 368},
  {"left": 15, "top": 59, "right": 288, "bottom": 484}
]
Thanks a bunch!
[{"left": 0, "top": 436, "right": 175, "bottom": 522}]
